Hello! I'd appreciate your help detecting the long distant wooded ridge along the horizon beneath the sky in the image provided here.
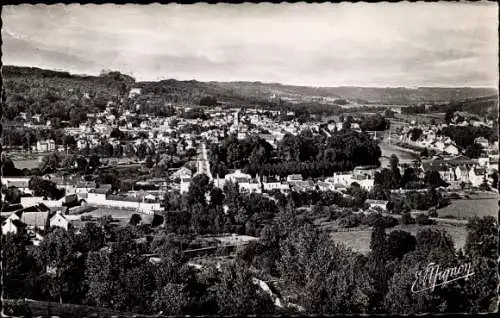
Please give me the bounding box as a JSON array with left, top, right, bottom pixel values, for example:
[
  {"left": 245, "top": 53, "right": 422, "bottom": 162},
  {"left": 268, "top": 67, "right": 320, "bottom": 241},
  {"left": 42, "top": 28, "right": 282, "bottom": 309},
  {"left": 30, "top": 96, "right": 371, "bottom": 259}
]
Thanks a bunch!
[{"left": 2, "top": 66, "right": 498, "bottom": 104}]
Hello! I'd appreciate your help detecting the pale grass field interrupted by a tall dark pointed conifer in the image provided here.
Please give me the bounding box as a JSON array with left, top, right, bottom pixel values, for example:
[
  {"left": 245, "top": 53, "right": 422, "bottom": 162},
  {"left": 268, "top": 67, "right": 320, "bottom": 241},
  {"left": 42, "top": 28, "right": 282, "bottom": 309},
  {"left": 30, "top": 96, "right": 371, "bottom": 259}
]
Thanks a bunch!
[{"left": 330, "top": 224, "right": 467, "bottom": 254}]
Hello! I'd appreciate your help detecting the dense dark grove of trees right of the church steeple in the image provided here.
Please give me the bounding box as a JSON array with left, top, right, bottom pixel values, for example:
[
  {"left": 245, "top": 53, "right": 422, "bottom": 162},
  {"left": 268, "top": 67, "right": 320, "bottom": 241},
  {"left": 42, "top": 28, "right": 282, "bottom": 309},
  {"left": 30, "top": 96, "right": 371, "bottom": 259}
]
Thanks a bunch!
[{"left": 209, "top": 129, "right": 381, "bottom": 178}]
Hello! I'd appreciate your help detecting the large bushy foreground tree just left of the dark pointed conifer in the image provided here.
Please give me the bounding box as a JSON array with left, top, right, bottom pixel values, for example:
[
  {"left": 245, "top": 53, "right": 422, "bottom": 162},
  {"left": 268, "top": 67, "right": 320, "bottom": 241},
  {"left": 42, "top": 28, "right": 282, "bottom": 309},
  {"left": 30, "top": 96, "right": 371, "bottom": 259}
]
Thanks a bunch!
[{"left": 278, "top": 225, "right": 368, "bottom": 314}]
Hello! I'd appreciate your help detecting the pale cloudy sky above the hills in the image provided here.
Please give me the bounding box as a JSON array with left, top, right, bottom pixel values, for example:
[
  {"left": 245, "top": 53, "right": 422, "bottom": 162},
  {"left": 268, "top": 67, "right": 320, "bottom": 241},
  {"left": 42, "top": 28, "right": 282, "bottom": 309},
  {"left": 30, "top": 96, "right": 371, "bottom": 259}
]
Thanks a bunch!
[{"left": 2, "top": 2, "right": 498, "bottom": 87}]
